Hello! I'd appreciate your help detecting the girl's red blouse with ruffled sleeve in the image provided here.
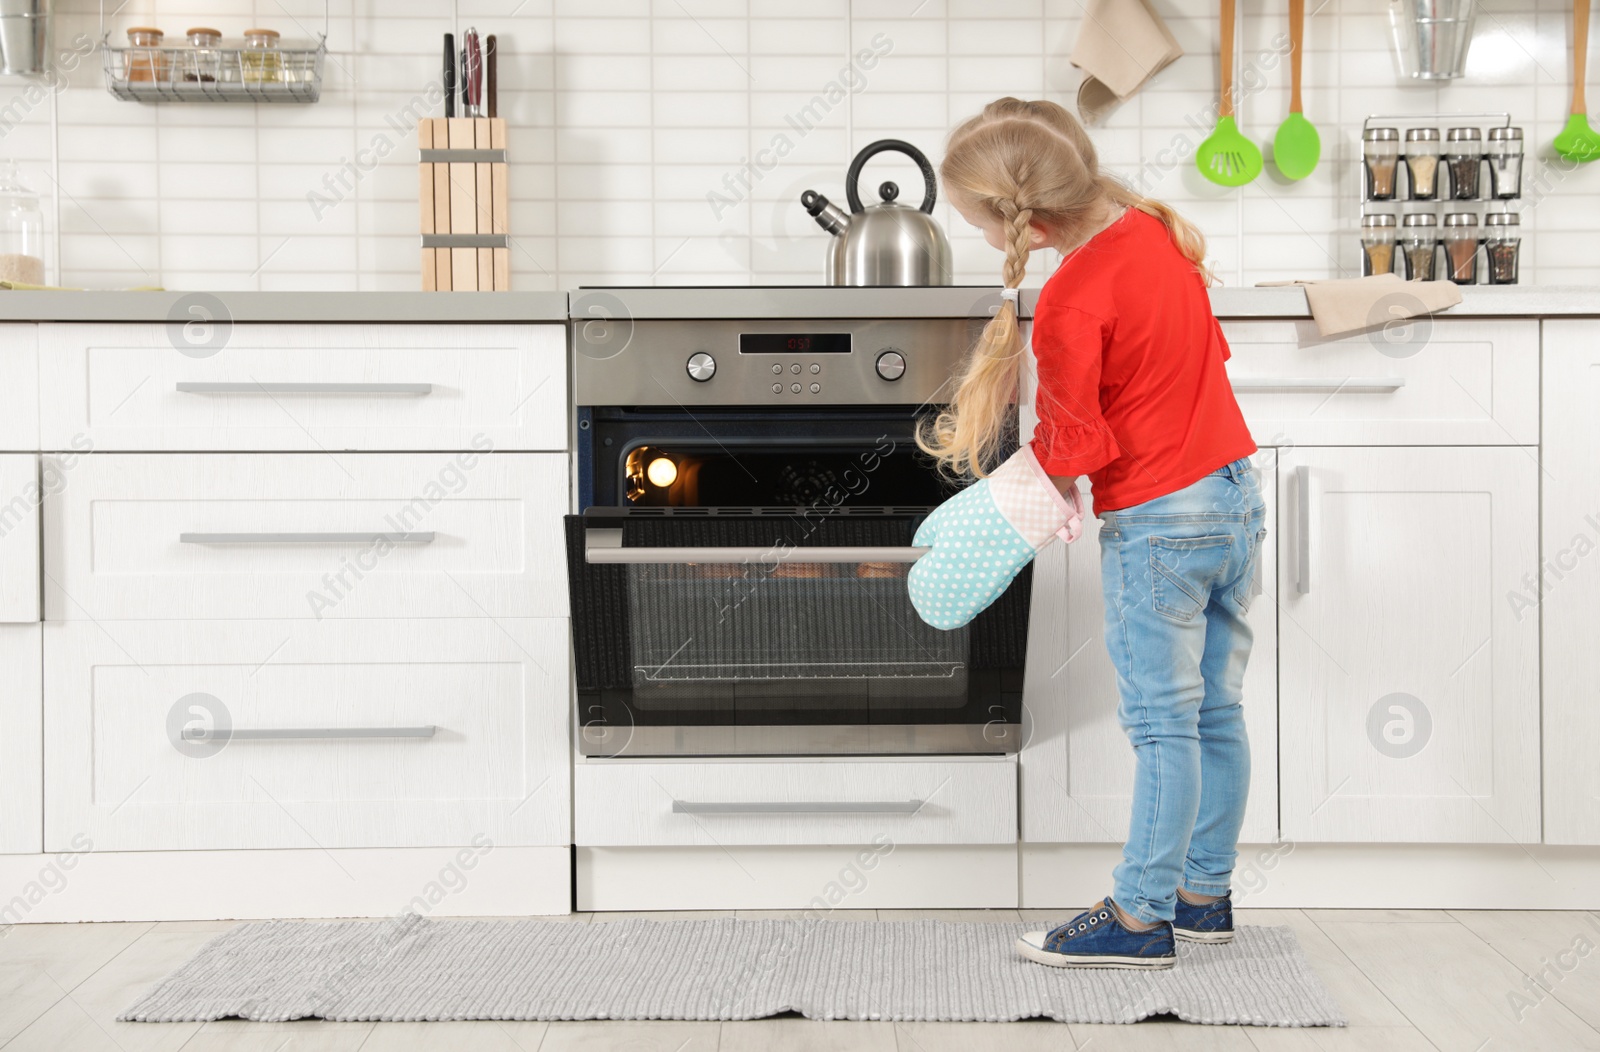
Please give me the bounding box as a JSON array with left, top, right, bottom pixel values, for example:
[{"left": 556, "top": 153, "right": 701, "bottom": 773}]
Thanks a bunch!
[{"left": 1032, "top": 208, "right": 1256, "bottom": 512}]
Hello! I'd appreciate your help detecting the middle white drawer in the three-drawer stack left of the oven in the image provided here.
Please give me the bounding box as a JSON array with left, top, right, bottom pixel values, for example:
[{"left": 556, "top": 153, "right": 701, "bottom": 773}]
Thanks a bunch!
[{"left": 45, "top": 452, "right": 568, "bottom": 620}]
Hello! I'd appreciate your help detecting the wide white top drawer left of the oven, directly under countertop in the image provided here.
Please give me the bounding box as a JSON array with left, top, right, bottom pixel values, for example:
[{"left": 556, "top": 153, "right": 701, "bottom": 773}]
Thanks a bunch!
[{"left": 38, "top": 325, "right": 566, "bottom": 451}]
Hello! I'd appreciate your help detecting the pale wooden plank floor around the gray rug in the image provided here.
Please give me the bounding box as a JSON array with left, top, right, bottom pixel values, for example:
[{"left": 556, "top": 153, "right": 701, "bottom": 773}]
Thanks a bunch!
[{"left": 0, "top": 910, "right": 1600, "bottom": 1052}]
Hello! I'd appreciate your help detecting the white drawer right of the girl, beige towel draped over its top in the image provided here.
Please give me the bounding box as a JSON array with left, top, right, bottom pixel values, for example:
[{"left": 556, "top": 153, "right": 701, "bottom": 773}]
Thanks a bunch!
[{"left": 1222, "top": 318, "right": 1539, "bottom": 446}]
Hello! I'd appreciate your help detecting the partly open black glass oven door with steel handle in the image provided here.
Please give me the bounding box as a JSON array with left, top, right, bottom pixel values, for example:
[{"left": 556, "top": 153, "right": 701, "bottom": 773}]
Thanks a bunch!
[{"left": 566, "top": 507, "right": 1032, "bottom": 756}]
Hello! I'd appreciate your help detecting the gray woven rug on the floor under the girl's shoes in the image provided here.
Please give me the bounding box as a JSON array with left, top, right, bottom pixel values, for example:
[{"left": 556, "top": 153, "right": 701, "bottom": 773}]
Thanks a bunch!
[{"left": 118, "top": 916, "right": 1346, "bottom": 1026}]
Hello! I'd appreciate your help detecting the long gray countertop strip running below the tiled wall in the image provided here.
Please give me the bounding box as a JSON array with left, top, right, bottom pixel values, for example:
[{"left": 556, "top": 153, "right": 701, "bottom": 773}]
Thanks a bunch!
[{"left": 0, "top": 285, "right": 1600, "bottom": 323}]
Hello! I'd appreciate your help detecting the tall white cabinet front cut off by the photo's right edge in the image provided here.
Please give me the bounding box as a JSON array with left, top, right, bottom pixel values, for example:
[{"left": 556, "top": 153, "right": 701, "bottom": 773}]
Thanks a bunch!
[{"left": 1536, "top": 321, "right": 1600, "bottom": 844}]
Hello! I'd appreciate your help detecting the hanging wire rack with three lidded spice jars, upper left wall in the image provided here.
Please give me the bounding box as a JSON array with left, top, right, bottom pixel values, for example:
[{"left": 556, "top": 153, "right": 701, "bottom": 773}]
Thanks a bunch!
[{"left": 99, "top": 0, "right": 328, "bottom": 102}]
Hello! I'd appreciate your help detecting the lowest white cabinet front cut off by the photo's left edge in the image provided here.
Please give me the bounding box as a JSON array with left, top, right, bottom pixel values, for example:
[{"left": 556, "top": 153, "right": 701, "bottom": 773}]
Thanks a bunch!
[{"left": 0, "top": 624, "right": 45, "bottom": 854}]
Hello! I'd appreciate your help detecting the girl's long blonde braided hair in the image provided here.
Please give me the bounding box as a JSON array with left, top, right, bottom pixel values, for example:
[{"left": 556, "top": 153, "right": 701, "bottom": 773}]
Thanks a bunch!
[{"left": 917, "top": 98, "right": 1211, "bottom": 478}]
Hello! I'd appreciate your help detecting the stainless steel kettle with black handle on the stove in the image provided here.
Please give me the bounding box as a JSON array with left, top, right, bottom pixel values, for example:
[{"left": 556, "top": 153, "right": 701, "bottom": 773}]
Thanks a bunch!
[{"left": 800, "top": 139, "right": 950, "bottom": 286}]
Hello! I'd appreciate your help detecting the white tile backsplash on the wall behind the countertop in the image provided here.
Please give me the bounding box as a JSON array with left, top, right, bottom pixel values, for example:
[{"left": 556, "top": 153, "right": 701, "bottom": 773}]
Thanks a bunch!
[{"left": 12, "top": 0, "right": 1600, "bottom": 289}]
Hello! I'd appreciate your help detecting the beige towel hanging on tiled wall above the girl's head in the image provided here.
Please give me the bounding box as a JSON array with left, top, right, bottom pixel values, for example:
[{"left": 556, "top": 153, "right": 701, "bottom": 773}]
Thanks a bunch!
[{"left": 1072, "top": 0, "right": 1184, "bottom": 125}]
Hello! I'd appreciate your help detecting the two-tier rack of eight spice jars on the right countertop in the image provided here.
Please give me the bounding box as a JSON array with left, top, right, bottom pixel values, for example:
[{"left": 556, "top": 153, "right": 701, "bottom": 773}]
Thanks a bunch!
[{"left": 1355, "top": 114, "right": 1525, "bottom": 285}]
